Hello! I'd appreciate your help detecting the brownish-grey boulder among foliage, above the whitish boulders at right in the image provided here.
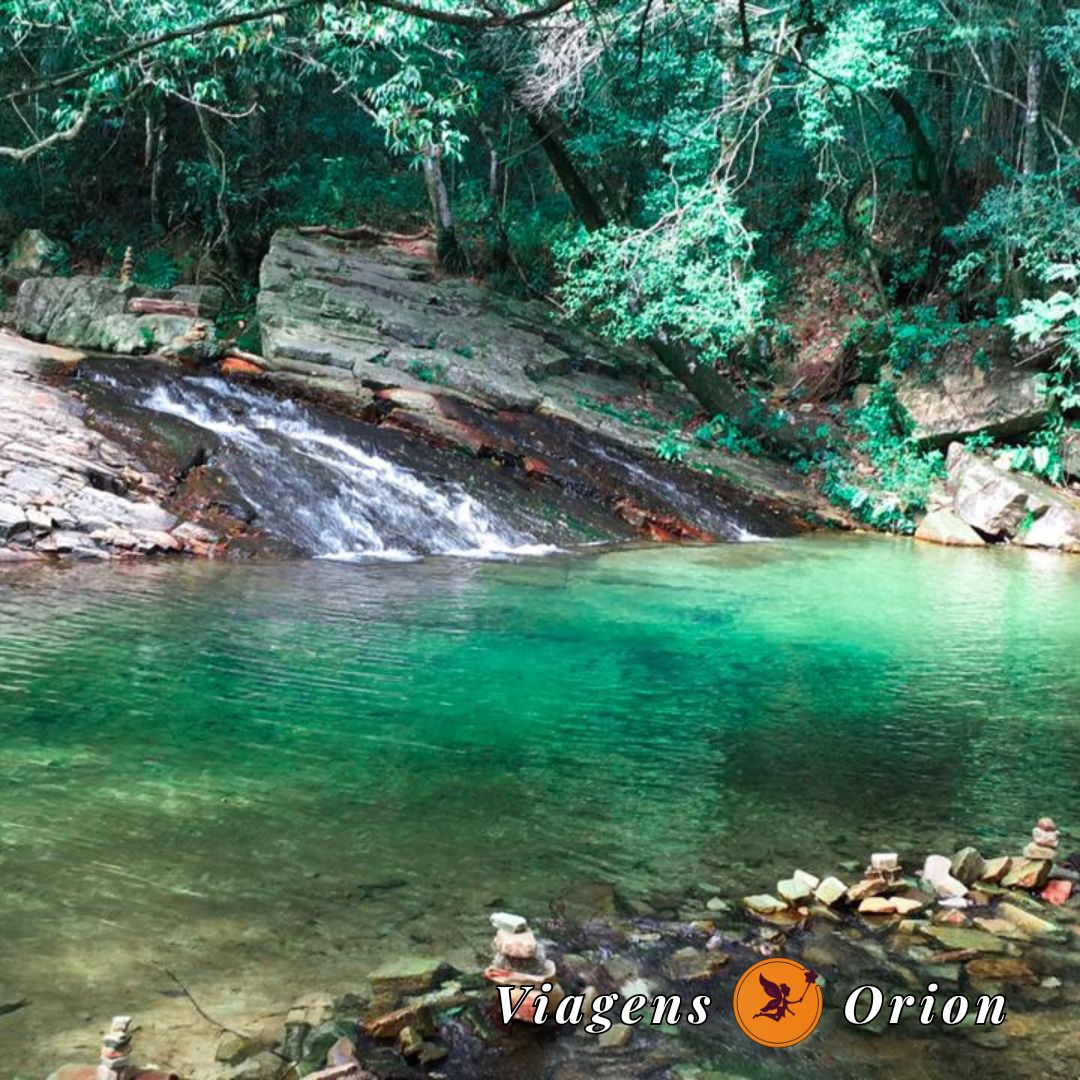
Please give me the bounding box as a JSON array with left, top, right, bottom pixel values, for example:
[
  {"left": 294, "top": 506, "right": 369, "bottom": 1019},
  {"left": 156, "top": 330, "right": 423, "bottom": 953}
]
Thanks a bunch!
[{"left": 895, "top": 353, "right": 1048, "bottom": 446}]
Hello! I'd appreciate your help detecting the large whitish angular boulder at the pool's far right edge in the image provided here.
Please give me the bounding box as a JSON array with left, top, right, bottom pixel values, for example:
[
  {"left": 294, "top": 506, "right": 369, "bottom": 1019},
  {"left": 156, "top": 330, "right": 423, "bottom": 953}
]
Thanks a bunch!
[{"left": 948, "top": 443, "right": 1080, "bottom": 551}]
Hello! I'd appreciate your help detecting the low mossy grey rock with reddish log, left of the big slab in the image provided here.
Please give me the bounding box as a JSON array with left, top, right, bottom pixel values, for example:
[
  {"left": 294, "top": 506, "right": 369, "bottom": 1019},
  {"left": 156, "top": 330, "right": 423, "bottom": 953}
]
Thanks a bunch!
[{"left": 15, "top": 275, "right": 222, "bottom": 360}]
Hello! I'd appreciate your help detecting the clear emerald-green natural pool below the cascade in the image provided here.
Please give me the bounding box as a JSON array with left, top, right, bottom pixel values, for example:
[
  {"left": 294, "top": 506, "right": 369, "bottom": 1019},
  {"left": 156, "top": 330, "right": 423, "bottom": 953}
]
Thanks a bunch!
[{"left": 0, "top": 537, "right": 1080, "bottom": 1075}]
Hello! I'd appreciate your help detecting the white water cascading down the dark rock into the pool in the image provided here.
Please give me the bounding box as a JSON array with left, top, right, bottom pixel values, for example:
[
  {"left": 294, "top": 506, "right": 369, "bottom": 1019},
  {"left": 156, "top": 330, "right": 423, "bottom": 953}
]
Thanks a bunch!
[{"left": 91, "top": 374, "right": 556, "bottom": 559}]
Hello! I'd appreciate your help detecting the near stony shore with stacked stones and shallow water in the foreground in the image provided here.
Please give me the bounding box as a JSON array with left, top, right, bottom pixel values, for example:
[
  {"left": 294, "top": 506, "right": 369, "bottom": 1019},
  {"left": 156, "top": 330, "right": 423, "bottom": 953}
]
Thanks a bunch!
[{"left": 31, "top": 819, "right": 1080, "bottom": 1080}]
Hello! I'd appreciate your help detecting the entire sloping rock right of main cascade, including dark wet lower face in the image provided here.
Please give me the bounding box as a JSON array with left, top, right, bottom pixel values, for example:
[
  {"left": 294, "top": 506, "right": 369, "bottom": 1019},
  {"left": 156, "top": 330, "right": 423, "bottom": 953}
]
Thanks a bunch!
[{"left": 250, "top": 231, "right": 823, "bottom": 542}]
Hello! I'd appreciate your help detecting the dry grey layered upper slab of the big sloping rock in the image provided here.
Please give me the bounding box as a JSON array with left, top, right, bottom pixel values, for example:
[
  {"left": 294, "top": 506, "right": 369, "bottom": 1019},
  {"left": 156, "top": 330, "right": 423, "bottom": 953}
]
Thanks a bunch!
[{"left": 258, "top": 232, "right": 665, "bottom": 409}]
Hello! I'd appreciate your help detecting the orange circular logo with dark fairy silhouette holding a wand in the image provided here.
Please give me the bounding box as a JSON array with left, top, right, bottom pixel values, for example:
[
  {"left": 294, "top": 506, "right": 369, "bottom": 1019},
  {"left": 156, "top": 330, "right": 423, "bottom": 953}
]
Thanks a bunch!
[{"left": 733, "top": 957, "right": 822, "bottom": 1047}]
